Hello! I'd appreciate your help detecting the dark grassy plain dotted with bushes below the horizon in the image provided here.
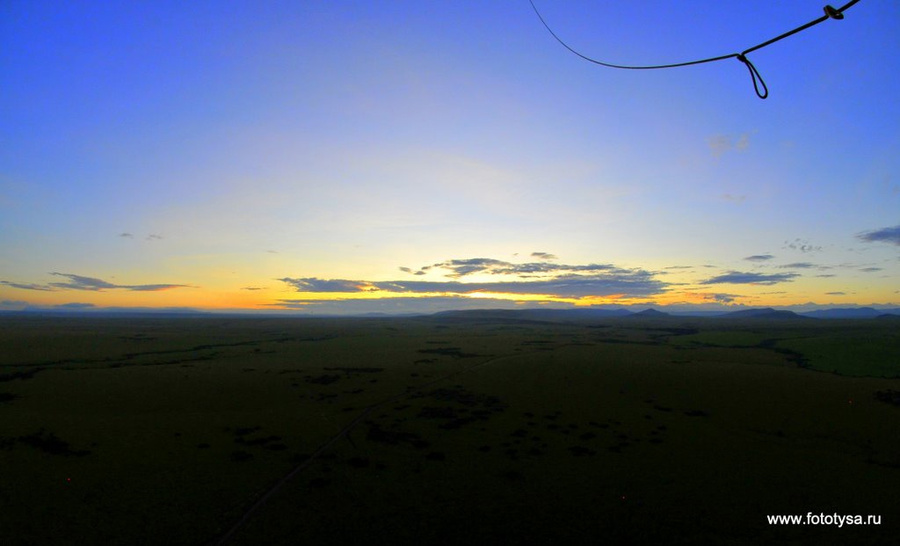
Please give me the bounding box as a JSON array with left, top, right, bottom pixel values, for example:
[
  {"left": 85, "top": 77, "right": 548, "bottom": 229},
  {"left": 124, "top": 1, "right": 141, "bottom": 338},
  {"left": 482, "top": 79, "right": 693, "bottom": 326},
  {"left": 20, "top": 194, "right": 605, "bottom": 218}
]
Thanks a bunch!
[{"left": 0, "top": 317, "right": 900, "bottom": 546}]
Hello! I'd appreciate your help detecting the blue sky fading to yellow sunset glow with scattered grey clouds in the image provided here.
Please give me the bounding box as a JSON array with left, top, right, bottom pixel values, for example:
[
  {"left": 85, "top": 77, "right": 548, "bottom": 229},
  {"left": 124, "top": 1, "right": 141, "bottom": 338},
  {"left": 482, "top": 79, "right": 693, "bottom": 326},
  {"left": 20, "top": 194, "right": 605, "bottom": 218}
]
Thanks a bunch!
[{"left": 0, "top": 0, "right": 900, "bottom": 314}]
